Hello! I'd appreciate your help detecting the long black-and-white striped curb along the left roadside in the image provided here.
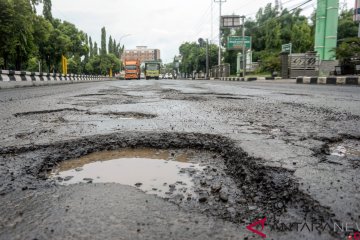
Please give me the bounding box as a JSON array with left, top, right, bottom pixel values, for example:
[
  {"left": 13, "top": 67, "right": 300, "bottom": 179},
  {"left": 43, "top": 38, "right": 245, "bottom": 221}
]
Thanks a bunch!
[{"left": 0, "top": 70, "right": 109, "bottom": 88}]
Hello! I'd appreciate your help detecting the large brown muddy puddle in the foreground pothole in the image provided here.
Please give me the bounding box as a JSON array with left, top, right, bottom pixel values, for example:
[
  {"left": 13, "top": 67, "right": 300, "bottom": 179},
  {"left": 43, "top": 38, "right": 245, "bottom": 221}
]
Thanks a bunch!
[{"left": 49, "top": 148, "right": 205, "bottom": 198}]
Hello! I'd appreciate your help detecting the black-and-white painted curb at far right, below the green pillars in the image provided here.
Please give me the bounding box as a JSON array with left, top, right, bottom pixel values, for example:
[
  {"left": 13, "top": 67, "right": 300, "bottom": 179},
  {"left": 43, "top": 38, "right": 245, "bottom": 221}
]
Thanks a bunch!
[{"left": 296, "top": 76, "right": 360, "bottom": 85}]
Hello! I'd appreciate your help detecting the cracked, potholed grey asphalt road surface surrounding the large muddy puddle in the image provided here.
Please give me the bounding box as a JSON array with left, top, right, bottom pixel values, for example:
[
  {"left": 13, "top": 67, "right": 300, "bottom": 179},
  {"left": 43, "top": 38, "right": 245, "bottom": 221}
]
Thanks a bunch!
[{"left": 0, "top": 80, "right": 360, "bottom": 239}]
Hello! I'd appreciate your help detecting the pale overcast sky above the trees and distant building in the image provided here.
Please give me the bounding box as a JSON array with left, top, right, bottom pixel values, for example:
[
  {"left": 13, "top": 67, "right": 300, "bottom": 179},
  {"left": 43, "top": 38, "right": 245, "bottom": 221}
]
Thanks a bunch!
[{"left": 43, "top": 0, "right": 355, "bottom": 63}]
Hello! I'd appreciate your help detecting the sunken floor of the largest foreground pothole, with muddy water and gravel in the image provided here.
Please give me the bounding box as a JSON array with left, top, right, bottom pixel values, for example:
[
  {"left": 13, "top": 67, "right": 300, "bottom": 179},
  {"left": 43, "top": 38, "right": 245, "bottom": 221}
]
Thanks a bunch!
[{"left": 47, "top": 145, "right": 250, "bottom": 220}]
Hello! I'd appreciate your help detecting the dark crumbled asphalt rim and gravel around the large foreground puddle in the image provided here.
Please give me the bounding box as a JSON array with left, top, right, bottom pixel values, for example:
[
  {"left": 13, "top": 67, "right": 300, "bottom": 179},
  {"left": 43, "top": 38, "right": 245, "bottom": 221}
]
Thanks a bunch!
[{"left": 0, "top": 132, "right": 338, "bottom": 233}]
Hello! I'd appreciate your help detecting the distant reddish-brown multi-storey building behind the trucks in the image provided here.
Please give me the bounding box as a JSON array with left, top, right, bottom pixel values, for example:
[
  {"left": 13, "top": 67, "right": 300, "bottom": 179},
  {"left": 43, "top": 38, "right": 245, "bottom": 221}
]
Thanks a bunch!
[{"left": 121, "top": 46, "right": 160, "bottom": 62}]
